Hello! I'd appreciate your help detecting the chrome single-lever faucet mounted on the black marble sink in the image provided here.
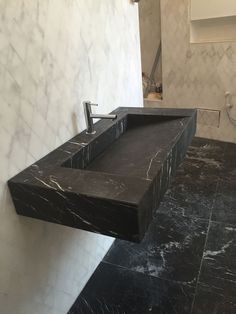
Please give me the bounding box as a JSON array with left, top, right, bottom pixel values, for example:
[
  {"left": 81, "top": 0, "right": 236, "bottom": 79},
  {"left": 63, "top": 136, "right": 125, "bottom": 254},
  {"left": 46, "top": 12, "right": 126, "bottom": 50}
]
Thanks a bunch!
[{"left": 83, "top": 101, "right": 117, "bottom": 134}]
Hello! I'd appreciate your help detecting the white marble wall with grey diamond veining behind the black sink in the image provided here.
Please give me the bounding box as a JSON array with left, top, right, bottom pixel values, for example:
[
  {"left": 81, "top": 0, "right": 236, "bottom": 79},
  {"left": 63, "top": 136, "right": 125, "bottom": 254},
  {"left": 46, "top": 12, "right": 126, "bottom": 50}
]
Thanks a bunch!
[{"left": 0, "top": 0, "right": 142, "bottom": 314}]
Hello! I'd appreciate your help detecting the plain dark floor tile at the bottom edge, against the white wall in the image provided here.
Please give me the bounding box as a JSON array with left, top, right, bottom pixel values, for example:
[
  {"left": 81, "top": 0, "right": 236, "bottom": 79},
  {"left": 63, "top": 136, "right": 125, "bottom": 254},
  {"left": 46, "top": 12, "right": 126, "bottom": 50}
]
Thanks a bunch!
[{"left": 69, "top": 263, "right": 194, "bottom": 314}]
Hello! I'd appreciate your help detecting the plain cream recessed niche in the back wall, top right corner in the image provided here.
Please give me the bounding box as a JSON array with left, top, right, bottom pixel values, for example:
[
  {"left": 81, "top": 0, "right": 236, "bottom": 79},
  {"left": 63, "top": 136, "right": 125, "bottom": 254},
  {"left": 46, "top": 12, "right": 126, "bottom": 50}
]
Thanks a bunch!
[{"left": 190, "top": 0, "right": 236, "bottom": 43}]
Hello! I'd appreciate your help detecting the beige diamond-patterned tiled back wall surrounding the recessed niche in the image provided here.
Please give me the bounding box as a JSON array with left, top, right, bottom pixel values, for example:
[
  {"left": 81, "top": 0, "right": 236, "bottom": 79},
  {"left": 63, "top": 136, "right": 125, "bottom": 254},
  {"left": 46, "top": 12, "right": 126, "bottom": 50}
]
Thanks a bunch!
[{"left": 161, "top": 0, "right": 236, "bottom": 142}]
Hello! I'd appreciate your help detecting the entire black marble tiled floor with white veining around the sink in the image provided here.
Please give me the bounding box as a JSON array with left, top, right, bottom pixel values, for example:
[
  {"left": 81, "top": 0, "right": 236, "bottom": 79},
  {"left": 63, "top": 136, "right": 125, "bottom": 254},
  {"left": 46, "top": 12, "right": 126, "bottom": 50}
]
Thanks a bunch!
[{"left": 69, "top": 138, "right": 236, "bottom": 314}]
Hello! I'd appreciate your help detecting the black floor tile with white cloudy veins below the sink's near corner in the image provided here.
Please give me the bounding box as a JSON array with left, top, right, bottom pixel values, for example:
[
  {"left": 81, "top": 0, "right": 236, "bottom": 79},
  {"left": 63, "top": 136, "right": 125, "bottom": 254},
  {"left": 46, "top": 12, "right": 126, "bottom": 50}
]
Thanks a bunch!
[{"left": 104, "top": 213, "right": 208, "bottom": 284}]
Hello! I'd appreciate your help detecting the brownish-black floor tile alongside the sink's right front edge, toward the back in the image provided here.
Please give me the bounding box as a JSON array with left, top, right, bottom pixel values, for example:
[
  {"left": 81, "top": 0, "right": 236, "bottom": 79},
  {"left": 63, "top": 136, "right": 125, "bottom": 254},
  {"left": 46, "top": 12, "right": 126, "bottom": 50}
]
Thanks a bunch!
[{"left": 158, "top": 138, "right": 221, "bottom": 219}]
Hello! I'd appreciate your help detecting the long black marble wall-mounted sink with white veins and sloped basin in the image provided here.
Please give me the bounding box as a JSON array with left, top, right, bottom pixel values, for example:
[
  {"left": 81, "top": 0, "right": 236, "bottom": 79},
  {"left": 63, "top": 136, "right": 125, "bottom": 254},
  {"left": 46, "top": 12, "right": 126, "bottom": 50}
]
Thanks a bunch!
[{"left": 8, "top": 107, "right": 196, "bottom": 242}]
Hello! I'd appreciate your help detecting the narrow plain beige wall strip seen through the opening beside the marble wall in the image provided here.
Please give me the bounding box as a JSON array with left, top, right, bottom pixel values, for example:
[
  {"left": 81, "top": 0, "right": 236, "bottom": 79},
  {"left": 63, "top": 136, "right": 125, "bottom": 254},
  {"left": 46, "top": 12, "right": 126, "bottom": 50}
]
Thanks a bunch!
[{"left": 139, "top": 0, "right": 161, "bottom": 81}]
